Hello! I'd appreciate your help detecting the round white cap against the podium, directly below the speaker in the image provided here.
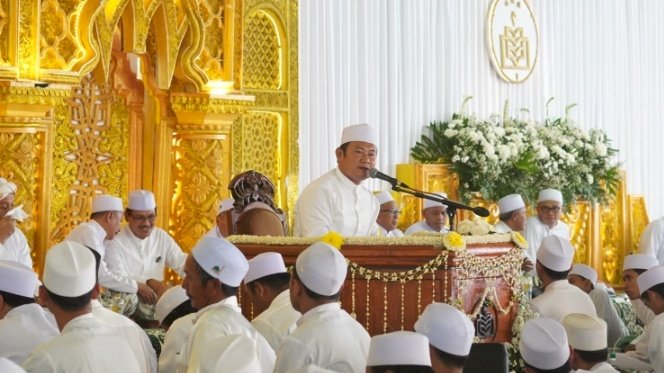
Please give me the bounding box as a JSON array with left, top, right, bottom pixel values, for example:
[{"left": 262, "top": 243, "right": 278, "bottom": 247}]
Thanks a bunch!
[{"left": 295, "top": 242, "right": 348, "bottom": 296}]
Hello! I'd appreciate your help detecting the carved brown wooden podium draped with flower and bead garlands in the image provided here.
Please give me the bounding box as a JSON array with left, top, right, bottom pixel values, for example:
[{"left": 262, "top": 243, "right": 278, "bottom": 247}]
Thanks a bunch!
[{"left": 229, "top": 233, "right": 525, "bottom": 342}]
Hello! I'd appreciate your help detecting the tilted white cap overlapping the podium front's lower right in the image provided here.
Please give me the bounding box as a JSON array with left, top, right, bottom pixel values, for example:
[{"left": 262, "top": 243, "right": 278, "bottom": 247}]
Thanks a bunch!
[{"left": 415, "top": 302, "right": 475, "bottom": 356}]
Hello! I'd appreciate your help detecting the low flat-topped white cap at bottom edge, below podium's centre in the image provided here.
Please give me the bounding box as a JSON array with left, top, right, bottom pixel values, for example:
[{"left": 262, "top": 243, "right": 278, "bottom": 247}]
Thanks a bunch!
[{"left": 367, "top": 331, "right": 431, "bottom": 367}]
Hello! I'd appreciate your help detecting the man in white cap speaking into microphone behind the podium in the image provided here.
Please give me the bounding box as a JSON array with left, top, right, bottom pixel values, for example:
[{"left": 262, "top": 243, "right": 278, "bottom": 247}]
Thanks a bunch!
[{"left": 294, "top": 124, "right": 380, "bottom": 237}]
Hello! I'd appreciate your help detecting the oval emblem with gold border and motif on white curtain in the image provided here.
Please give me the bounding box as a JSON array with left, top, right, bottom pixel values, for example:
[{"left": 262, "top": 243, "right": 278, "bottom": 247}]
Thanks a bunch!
[{"left": 486, "top": 0, "right": 539, "bottom": 83}]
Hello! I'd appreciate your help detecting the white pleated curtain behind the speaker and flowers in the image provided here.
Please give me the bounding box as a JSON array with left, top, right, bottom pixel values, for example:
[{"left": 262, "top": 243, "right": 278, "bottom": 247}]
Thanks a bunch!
[{"left": 299, "top": 0, "right": 664, "bottom": 219}]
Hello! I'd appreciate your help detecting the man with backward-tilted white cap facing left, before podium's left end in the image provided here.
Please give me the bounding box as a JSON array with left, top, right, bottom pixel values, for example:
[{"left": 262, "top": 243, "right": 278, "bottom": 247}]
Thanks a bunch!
[{"left": 179, "top": 236, "right": 275, "bottom": 372}]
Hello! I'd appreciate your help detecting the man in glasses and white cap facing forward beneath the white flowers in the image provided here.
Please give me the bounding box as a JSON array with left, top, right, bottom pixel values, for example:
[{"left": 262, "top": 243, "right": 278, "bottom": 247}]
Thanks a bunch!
[{"left": 525, "top": 189, "right": 570, "bottom": 260}]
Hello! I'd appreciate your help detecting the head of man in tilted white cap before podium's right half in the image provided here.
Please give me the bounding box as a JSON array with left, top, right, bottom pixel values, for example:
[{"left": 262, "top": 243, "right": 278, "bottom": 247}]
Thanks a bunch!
[{"left": 415, "top": 303, "right": 475, "bottom": 373}]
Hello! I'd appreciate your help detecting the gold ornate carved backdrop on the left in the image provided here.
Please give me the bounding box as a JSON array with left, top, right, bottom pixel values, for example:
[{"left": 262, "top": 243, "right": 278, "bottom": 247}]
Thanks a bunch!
[{"left": 0, "top": 0, "right": 298, "bottom": 272}]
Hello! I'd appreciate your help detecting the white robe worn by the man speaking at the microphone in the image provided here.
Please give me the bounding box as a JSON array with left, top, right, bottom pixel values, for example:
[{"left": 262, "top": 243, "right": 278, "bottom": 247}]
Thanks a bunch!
[{"left": 294, "top": 168, "right": 380, "bottom": 237}]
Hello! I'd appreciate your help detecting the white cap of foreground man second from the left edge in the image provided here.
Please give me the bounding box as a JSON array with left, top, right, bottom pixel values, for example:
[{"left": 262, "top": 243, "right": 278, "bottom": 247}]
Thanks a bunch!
[{"left": 44, "top": 241, "right": 97, "bottom": 298}]
